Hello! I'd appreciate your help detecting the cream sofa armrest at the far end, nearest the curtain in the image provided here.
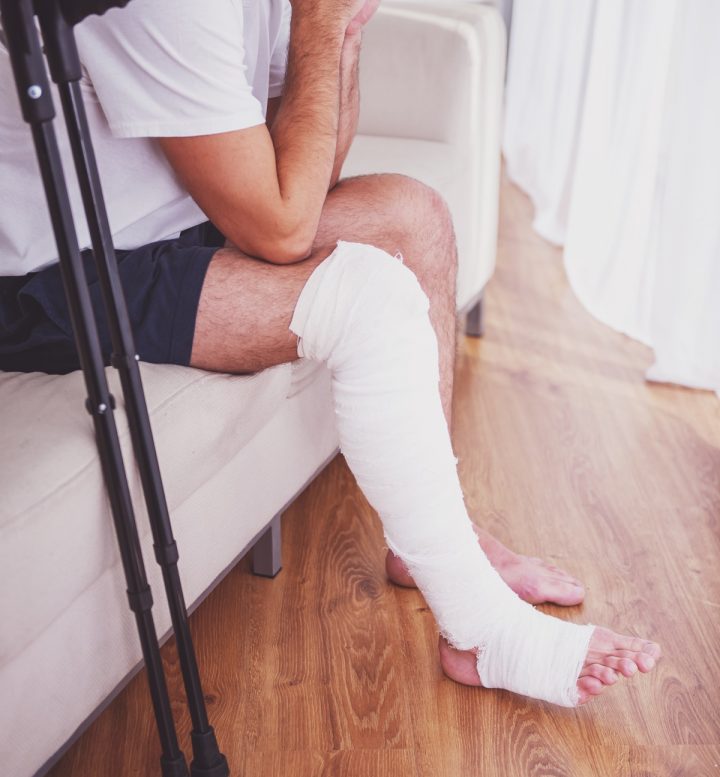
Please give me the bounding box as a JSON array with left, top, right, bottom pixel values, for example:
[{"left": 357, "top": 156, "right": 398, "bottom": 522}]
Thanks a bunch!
[{"left": 356, "top": 0, "right": 506, "bottom": 311}]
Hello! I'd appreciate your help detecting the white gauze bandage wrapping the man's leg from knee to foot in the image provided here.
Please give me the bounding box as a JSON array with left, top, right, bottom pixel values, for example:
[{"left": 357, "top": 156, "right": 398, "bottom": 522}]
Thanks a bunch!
[{"left": 290, "top": 243, "right": 593, "bottom": 706}]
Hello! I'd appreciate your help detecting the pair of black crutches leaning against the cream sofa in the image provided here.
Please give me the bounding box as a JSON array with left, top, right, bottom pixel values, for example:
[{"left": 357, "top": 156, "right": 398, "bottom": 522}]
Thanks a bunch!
[{"left": 0, "top": 0, "right": 229, "bottom": 777}]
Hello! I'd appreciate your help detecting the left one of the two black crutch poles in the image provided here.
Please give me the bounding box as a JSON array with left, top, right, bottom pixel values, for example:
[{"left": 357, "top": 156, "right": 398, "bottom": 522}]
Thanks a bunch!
[{"left": 0, "top": 0, "right": 187, "bottom": 777}]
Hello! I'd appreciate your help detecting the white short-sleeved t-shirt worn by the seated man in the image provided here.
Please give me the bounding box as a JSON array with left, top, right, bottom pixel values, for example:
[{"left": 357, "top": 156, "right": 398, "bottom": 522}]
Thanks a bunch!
[{"left": 0, "top": 0, "right": 290, "bottom": 276}]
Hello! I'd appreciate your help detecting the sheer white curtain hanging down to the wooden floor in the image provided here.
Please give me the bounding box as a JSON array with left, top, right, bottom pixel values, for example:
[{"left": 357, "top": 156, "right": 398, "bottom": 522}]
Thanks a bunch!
[{"left": 503, "top": 0, "right": 720, "bottom": 391}]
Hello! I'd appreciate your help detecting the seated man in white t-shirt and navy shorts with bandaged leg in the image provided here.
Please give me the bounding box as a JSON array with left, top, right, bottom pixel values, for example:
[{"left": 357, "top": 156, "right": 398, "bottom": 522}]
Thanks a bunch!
[{"left": 0, "top": 0, "right": 660, "bottom": 706}]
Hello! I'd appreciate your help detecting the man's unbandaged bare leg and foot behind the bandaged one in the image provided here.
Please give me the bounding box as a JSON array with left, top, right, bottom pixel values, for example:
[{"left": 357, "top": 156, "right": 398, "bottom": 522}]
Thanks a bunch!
[{"left": 317, "top": 175, "right": 585, "bottom": 605}]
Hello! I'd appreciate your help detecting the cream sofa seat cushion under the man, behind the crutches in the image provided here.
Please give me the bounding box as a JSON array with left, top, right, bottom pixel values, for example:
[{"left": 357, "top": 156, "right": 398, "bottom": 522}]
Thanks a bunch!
[{"left": 0, "top": 364, "right": 296, "bottom": 664}]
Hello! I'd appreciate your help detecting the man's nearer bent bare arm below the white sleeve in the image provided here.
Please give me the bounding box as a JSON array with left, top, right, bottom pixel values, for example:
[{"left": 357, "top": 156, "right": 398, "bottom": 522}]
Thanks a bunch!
[{"left": 160, "top": 0, "right": 359, "bottom": 264}]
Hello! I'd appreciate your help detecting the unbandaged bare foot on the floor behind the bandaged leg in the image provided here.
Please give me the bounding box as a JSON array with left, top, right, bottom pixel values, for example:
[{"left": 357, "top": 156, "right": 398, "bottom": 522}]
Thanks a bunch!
[{"left": 385, "top": 526, "right": 585, "bottom": 607}]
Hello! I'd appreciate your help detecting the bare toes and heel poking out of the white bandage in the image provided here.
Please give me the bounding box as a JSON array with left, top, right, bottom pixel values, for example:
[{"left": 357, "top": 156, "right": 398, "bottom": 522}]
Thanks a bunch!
[{"left": 440, "top": 627, "right": 661, "bottom": 704}]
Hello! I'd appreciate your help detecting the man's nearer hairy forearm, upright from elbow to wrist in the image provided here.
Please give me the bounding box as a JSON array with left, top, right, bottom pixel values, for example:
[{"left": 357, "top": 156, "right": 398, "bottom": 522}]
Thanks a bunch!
[{"left": 271, "top": 13, "right": 345, "bottom": 251}]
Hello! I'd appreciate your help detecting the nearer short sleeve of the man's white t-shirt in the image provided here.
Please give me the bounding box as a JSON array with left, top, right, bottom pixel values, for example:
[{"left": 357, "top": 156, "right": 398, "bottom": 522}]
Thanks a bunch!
[{"left": 77, "top": 0, "right": 265, "bottom": 138}]
